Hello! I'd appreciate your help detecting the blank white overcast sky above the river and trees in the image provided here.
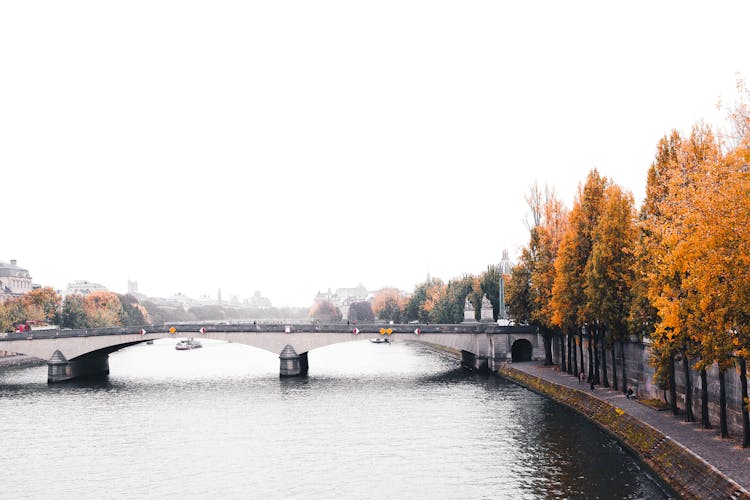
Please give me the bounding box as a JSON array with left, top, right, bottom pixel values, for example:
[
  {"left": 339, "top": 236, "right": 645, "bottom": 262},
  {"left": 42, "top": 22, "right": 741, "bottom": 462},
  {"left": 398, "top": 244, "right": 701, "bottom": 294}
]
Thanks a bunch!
[{"left": 0, "top": 0, "right": 750, "bottom": 306}]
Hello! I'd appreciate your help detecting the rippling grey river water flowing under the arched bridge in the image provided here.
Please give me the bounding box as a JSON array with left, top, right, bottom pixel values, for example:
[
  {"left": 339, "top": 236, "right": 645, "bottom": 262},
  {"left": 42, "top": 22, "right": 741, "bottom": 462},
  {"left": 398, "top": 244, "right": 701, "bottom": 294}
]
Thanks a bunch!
[{"left": 0, "top": 339, "right": 668, "bottom": 500}]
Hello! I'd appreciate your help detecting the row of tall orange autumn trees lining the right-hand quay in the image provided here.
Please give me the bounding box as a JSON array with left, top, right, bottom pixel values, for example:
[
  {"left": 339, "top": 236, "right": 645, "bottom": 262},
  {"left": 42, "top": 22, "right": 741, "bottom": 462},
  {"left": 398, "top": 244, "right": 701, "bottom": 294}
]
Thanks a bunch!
[{"left": 507, "top": 82, "right": 750, "bottom": 447}]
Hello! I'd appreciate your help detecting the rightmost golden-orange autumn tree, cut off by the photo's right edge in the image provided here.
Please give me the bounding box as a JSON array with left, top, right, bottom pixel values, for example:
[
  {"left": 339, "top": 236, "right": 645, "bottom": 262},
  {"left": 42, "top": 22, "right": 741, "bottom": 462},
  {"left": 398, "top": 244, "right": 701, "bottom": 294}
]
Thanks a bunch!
[{"left": 681, "top": 92, "right": 750, "bottom": 447}]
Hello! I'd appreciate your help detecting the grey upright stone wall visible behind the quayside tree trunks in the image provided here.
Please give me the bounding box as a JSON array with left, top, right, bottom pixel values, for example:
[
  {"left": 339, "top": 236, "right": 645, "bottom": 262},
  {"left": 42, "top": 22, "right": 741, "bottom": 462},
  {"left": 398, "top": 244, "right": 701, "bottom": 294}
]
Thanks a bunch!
[{"left": 554, "top": 340, "right": 742, "bottom": 436}]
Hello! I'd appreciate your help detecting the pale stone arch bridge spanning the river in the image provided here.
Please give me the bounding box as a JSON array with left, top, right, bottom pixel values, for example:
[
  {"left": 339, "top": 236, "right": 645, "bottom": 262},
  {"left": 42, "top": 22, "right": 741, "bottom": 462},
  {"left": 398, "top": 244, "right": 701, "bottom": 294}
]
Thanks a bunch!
[{"left": 0, "top": 323, "right": 544, "bottom": 383}]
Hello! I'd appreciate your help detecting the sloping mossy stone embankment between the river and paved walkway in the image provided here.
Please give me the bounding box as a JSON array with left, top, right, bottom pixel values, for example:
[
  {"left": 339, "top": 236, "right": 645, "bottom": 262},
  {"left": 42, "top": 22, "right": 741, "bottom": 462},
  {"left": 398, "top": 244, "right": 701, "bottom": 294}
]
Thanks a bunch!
[{"left": 498, "top": 364, "right": 750, "bottom": 499}]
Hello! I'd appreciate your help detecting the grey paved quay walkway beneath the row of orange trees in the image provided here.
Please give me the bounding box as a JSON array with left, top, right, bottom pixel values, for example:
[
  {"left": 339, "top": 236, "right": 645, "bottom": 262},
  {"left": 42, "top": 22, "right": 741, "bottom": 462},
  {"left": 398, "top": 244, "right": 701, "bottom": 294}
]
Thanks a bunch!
[{"left": 512, "top": 362, "right": 750, "bottom": 491}]
